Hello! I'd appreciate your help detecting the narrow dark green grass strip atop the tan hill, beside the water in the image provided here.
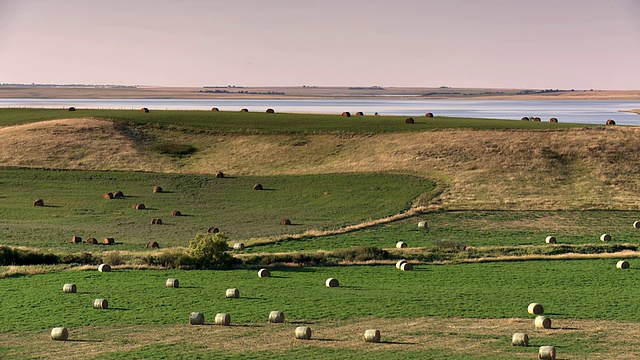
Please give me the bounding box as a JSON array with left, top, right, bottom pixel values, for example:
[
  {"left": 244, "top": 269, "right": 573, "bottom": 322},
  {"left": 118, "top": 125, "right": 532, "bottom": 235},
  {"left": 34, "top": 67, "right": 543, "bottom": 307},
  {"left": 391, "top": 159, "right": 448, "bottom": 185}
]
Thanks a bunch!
[{"left": 0, "top": 108, "right": 595, "bottom": 134}]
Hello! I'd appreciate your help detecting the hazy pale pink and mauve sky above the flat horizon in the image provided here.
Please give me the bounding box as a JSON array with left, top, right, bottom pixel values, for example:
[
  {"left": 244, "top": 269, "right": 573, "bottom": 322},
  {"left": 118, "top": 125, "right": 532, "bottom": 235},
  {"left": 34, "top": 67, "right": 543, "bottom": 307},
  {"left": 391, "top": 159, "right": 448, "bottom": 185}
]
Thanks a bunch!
[{"left": 0, "top": 0, "right": 640, "bottom": 89}]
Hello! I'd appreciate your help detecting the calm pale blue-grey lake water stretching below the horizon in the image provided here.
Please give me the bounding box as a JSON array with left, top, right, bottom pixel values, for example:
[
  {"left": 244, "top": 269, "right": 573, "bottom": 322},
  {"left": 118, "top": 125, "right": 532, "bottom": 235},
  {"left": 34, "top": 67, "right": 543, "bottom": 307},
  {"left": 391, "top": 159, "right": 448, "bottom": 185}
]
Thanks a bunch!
[{"left": 0, "top": 98, "right": 640, "bottom": 125}]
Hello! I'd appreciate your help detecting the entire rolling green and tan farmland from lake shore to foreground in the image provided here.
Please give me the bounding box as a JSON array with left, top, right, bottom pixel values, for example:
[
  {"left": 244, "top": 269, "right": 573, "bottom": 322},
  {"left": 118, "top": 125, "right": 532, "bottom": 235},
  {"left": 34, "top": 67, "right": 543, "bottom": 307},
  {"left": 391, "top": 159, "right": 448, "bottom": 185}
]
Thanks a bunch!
[{"left": 0, "top": 109, "right": 640, "bottom": 359}]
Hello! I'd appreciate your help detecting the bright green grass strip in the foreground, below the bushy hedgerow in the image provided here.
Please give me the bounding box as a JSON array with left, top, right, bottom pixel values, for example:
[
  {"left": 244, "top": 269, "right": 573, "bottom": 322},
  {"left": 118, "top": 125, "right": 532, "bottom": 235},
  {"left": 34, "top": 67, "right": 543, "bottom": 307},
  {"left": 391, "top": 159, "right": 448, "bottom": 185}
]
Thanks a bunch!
[{"left": 0, "top": 259, "right": 640, "bottom": 333}]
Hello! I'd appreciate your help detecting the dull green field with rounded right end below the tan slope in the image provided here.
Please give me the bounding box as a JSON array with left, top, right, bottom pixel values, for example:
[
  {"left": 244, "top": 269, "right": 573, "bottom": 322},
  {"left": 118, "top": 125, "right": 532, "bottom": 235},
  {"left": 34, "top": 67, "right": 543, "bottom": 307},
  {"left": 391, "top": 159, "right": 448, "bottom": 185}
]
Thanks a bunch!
[{"left": 0, "top": 169, "right": 433, "bottom": 252}]
